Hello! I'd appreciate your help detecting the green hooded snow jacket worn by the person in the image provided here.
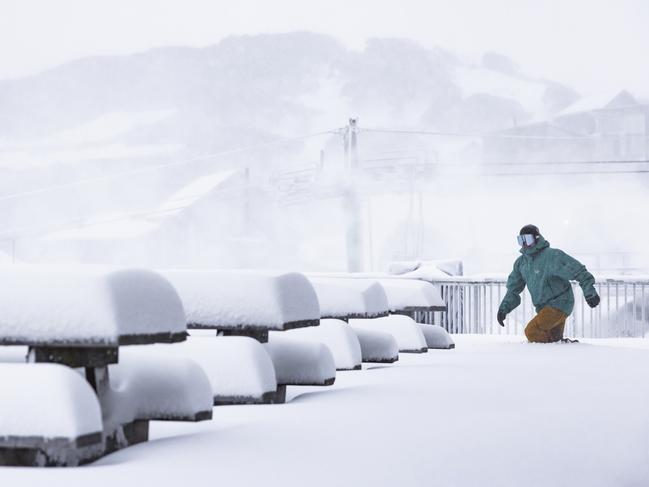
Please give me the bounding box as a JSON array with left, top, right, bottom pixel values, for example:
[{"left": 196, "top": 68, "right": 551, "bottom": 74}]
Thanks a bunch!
[{"left": 499, "top": 237, "right": 597, "bottom": 315}]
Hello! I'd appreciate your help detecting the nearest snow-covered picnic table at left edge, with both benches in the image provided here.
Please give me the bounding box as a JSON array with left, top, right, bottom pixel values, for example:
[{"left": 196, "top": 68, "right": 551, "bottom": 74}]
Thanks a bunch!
[{"left": 0, "top": 266, "right": 212, "bottom": 465}]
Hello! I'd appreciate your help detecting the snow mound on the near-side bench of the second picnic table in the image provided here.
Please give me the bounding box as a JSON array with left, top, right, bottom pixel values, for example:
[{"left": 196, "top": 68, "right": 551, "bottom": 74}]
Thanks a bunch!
[{"left": 138, "top": 336, "right": 277, "bottom": 398}]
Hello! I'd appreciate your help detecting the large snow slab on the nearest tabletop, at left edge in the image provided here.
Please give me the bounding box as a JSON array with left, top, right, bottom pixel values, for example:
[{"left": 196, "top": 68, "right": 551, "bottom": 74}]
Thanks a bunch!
[{"left": 0, "top": 266, "right": 186, "bottom": 346}]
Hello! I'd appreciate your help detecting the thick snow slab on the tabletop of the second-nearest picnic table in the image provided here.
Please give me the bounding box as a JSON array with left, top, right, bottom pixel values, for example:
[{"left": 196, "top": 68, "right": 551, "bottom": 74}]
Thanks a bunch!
[{"left": 162, "top": 270, "right": 320, "bottom": 330}]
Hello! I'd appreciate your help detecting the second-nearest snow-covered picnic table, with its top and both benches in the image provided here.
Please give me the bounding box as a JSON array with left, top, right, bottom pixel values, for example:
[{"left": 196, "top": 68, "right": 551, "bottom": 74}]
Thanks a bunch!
[{"left": 162, "top": 270, "right": 336, "bottom": 404}]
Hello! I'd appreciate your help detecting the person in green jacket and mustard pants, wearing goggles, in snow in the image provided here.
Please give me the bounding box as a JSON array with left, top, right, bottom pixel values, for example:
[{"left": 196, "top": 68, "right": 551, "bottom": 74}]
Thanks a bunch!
[{"left": 497, "top": 225, "right": 600, "bottom": 343}]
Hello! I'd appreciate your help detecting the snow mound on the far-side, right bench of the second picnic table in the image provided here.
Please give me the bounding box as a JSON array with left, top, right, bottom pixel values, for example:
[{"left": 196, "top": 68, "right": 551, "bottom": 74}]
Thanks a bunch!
[{"left": 264, "top": 333, "right": 336, "bottom": 386}]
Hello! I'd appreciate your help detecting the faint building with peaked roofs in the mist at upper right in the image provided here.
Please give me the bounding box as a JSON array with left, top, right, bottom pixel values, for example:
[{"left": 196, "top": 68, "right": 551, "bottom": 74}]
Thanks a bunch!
[{"left": 483, "top": 91, "right": 649, "bottom": 163}]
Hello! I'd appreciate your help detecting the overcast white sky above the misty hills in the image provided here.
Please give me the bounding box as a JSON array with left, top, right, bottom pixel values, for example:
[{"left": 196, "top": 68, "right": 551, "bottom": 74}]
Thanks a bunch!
[{"left": 0, "top": 0, "right": 649, "bottom": 96}]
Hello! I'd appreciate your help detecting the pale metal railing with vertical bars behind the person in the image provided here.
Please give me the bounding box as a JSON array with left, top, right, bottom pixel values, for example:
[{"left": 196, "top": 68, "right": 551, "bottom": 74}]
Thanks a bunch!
[{"left": 414, "top": 276, "right": 649, "bottom": 338}]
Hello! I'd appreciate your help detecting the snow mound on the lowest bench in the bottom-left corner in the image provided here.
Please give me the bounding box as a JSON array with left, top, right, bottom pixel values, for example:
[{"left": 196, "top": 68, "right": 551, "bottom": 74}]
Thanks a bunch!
[{"left": 0, "top": 363, "right": 102, "bottom": 439}]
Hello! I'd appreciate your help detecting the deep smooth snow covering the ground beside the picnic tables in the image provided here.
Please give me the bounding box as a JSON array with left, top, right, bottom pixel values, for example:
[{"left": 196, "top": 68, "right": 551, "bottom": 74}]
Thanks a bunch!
[{"left": 0, "top": 335, "right": 649, "bottom": 487}]
